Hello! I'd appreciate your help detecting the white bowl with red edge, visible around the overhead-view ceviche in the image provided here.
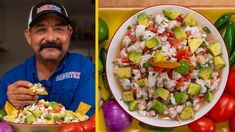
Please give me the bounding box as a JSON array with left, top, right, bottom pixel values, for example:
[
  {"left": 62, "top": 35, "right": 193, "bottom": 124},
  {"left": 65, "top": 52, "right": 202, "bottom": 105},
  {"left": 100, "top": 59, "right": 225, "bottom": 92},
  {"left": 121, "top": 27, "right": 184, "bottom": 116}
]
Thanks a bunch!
[{"left": 106, "top": 5, "right": 229, "bottom": 127}]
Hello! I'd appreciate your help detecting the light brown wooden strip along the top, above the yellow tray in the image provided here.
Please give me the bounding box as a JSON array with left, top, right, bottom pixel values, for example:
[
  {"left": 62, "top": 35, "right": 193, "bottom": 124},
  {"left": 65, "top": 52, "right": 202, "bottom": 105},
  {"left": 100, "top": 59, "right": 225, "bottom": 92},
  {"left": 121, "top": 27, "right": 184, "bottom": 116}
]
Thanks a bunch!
[{"left": 99, "top": 0, "right": 235, "bottom": 8}]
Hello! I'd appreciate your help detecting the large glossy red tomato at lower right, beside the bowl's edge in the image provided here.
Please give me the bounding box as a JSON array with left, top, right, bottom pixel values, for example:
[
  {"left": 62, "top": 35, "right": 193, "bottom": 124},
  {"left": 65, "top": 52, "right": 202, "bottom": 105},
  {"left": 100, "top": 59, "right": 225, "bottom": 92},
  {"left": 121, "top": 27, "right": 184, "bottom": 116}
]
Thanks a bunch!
[{"left": 209, "top": 93, "right": 235, "bottom": 122}]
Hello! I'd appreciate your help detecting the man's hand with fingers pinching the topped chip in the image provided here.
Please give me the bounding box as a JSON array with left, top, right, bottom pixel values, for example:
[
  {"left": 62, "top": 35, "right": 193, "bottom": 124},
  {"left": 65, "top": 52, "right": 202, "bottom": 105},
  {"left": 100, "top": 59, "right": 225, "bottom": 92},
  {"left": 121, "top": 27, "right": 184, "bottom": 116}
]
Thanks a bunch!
[{"left": 7, "top": 81, "right": 38, "bottom": 109}]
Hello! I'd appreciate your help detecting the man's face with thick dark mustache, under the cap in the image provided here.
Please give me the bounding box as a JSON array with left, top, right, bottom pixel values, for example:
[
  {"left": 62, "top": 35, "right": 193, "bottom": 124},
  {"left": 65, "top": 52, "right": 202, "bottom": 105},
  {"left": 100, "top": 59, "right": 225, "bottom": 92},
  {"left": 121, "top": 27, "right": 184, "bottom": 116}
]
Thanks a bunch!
[{"left": 25, "top": 14, "right": 72, "bottom": 61}]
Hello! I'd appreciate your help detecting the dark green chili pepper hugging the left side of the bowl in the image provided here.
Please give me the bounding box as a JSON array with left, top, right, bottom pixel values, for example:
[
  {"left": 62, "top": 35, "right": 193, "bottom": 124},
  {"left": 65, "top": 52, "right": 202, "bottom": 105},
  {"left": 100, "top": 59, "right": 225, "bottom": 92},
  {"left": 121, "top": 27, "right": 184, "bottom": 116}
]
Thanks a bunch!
[{"left": 100, "top": 48, "right": 112, "bottom": 101}]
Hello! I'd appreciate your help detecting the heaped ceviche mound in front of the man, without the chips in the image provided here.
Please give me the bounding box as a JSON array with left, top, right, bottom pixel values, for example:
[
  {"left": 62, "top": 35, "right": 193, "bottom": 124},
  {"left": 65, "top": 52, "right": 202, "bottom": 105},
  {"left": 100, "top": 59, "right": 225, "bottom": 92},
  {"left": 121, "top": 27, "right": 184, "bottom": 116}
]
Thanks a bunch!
[{"left": 3, "top": 99, "right": 89, "bottom": 124}]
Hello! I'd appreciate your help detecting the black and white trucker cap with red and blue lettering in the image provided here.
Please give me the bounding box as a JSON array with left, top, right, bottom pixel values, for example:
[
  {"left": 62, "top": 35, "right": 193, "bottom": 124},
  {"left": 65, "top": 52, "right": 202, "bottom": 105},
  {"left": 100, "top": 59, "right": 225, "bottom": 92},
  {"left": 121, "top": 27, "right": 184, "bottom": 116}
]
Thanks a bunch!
[{"left": 28, "top": 0, "right": 71, "bottom": 28}]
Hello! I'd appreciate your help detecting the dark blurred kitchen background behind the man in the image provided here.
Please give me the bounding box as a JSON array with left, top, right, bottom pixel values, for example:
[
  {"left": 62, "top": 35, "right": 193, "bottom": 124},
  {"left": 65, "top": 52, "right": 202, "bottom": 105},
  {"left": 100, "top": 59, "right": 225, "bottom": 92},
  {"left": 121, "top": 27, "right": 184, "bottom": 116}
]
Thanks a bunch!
[{"left": 0, "top": 0, "right": 95, "bottom": 78}]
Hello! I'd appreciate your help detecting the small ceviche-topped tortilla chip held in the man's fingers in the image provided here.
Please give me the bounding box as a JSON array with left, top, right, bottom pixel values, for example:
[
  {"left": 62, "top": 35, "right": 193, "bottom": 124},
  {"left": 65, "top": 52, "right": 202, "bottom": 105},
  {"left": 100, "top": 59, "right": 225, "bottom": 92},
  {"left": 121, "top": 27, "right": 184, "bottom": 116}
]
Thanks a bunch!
[{"left": 29, "top": 83, "right": 48, "bottom": 95}]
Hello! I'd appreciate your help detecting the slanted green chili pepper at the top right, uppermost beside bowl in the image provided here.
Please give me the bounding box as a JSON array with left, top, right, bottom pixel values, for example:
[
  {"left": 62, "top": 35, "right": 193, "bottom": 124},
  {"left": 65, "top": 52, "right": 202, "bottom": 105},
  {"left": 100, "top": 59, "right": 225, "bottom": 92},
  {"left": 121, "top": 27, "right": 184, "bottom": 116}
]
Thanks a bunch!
[{"left": 214, "top": 13, "right": 234, "bottom": 30}]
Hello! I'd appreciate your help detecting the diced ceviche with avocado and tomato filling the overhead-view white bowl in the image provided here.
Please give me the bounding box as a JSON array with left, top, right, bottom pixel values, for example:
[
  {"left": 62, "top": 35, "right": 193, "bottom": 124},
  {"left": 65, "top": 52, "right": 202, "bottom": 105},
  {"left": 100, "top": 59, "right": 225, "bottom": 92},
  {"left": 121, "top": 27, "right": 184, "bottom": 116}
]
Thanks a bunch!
[{"left": 114, "top": 8, "right": 226, "bottom": 120}]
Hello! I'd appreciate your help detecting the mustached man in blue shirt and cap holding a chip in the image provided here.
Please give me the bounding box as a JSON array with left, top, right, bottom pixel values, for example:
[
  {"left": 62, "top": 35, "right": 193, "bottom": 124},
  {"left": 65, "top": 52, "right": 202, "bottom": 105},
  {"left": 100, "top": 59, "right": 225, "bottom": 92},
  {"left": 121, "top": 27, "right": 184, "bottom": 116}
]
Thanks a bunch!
[{"left": 0, "top": 0, "right": 95, "bottom": 116}]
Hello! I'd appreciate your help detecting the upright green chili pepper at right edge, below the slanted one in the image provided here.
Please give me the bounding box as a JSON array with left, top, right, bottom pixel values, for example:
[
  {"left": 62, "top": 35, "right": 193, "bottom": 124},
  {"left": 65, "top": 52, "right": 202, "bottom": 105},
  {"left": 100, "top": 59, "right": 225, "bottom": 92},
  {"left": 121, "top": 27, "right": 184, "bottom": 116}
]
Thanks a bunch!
[{"left": 224, "top": 21, "right": 234, "bottom": 56}]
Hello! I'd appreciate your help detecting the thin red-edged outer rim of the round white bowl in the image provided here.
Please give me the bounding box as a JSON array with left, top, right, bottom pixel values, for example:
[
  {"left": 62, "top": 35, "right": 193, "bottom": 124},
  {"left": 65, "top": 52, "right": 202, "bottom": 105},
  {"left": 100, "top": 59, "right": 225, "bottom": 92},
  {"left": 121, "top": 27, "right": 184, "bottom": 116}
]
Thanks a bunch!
[{"left": 105, "top": 4, "right": 230, "bottom": 128}]
